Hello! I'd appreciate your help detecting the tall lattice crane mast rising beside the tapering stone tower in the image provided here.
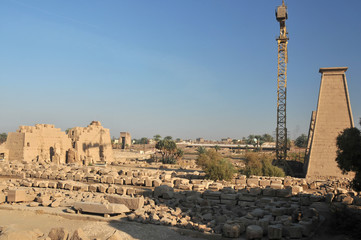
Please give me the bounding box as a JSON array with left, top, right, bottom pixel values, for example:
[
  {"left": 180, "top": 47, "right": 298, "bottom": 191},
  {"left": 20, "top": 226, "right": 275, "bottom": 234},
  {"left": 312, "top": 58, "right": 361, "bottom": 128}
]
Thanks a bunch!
[{"left": 276, "top": 0, "right": 288, "bottom": 167}]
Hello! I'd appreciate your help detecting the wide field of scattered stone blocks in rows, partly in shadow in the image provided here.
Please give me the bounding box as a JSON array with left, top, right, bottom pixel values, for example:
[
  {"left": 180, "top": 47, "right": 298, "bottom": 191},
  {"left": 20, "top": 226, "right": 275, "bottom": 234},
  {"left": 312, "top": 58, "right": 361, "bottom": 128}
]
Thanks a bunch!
[{"left": 0, "top": 158, "right": 361, "bottom": 239}]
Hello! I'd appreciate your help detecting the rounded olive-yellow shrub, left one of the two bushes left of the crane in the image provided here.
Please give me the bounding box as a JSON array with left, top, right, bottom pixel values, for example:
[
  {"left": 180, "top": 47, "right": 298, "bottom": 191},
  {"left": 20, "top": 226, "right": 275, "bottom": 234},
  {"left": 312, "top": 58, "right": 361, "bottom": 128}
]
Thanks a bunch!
[{"left": 196, "top": 149, "right": 236, "bottom": 180}]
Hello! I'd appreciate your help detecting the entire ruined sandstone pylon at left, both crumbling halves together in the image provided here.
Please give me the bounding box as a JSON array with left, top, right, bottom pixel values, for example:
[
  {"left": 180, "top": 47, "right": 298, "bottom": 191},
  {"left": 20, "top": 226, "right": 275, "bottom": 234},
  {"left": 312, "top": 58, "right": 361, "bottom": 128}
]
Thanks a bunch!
[{"left": 0, "top": 121, "right": 113, "bottom": 164}]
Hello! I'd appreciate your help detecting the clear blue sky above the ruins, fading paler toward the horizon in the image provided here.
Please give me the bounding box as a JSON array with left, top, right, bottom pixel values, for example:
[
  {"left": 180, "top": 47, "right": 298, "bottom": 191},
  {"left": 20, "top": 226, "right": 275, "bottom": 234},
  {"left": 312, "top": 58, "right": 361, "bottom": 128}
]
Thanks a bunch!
[{"left": 0, "top": 0, "right": 361, "bottom": 139}]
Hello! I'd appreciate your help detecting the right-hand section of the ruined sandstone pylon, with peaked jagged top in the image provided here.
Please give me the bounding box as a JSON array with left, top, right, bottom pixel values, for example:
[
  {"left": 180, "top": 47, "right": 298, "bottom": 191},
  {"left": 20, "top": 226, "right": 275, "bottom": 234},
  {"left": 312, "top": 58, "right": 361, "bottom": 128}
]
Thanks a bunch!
[{"left": 68, "top": 121, "right": 113, "bottom": 164}]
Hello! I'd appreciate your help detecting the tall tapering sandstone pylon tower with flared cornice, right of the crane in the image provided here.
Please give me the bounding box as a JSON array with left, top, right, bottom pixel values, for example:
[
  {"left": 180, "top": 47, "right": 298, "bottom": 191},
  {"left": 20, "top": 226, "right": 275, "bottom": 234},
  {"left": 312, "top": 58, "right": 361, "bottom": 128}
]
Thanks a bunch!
[{"left": 304, "top": 67, "right": 354, "bottom": 177}]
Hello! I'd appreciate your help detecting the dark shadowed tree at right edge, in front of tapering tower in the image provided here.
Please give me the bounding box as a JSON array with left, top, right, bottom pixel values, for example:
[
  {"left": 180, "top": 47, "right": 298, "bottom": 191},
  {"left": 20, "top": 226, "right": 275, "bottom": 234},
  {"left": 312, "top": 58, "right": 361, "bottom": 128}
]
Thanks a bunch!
[{"left": 336, "top": 119, "right": 361, "bottom": 191}]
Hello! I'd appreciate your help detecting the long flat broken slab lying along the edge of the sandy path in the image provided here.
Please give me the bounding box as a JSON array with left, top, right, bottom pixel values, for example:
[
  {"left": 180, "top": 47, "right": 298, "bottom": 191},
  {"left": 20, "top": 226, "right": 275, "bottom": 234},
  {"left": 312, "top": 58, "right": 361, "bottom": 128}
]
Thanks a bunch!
[{"left": 73, "top": 202, "right": 130, "bottom": 215}]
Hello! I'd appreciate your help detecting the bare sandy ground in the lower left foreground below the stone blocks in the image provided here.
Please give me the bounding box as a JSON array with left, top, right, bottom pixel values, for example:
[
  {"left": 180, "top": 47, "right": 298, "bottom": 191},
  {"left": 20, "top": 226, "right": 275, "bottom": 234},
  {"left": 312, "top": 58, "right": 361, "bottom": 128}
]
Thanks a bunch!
[{"left": 0, "top": 205, "right": 220, "bottom": 240}]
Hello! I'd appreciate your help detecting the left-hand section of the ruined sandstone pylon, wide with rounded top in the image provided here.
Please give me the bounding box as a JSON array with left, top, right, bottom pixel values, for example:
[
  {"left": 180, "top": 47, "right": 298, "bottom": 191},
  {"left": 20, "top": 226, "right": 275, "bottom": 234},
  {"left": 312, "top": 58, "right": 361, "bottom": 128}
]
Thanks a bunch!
[{"left": 6, "top": 124, "right": 71, "bottom": 163}]
